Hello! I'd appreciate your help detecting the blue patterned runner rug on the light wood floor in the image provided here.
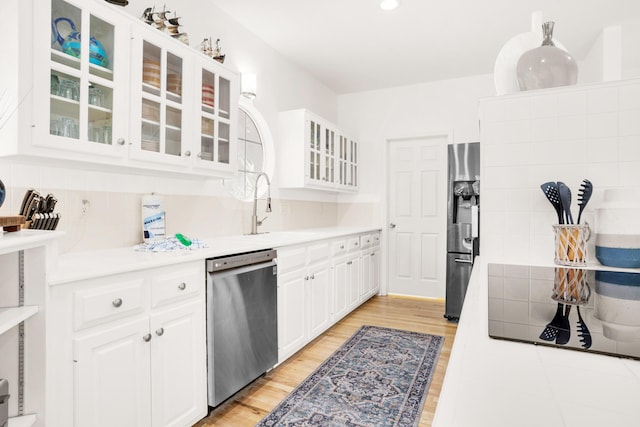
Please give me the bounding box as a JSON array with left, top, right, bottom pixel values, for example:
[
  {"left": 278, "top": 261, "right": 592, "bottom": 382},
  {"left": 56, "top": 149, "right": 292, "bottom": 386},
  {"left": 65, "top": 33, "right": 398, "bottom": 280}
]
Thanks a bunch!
[{"left": 257, "top": 326, "right": 444, "bottom": 427}]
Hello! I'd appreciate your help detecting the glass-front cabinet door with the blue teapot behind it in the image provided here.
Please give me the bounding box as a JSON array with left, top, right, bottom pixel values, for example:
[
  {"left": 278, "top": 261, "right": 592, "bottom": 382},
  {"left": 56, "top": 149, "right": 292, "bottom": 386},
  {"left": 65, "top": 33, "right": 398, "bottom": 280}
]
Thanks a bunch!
[{"left": 33, "top": 0, "right": 129, "bottom": 156}]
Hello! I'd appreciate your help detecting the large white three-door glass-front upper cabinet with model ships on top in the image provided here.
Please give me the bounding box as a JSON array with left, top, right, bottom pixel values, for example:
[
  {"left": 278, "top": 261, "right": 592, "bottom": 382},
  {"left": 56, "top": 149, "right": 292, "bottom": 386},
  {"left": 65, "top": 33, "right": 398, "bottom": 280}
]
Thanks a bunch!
[{"left": 0, "top": 0, "right": 239, "bottom": 177}]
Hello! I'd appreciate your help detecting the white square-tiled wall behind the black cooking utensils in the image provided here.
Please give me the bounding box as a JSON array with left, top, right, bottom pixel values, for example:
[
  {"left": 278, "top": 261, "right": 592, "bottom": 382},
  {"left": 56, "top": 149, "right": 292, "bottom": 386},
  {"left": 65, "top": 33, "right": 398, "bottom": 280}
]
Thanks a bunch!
[{"left": 480, "top": 79, "right": 640, "bottom": 264}]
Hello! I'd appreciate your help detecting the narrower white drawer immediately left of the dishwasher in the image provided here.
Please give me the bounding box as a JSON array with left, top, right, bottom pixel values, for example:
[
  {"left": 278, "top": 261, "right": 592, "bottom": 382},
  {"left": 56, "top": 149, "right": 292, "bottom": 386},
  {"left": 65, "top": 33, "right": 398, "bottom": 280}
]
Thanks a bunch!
[{"left": 151, "top": 261, "right": 206, "bottom": 308}]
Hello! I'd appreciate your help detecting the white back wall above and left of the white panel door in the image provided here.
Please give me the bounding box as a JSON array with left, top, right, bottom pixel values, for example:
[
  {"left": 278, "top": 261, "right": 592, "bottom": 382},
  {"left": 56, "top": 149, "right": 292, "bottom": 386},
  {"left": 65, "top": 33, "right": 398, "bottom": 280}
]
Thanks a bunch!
[{"left": 338, "top": 74, "right": 495, "bottom": 221}]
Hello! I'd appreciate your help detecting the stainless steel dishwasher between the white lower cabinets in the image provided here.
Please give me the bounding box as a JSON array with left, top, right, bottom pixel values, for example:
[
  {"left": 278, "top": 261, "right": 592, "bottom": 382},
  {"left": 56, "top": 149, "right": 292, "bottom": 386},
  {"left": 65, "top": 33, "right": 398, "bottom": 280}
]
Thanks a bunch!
[{"left": 207, "top": 250, "right": 278, "bottom": 406}]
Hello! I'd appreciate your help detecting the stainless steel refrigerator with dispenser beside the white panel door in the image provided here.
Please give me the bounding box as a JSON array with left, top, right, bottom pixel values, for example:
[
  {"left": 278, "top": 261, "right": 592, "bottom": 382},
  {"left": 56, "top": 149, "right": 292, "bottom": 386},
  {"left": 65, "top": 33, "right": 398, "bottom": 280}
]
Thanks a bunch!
[{"left": 444, "top": 142, "right": 480, "bottom": 321}]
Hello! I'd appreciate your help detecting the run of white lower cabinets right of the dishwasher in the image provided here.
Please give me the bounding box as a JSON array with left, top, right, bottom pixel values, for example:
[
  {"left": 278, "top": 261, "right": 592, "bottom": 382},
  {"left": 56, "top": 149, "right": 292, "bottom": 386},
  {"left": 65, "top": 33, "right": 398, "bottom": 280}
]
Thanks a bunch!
[{"left": 278, "top": 233, "right": 380, "bottom": 363}]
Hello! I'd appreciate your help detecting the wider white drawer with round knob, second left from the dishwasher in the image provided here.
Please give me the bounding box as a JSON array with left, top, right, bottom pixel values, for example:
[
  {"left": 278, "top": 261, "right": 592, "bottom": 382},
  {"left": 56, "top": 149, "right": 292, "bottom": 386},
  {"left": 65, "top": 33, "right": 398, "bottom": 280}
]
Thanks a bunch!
[{"left": 73, "top": 278, "right": 145, "bottom": 331}]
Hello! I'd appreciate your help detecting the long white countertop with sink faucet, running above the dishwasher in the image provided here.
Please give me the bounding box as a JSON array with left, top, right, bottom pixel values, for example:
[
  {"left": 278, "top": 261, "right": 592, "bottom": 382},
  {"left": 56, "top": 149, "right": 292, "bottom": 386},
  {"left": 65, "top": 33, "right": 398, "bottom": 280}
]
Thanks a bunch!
[{"left": 47, "top": 227, "right": 380, "bottom": 286}]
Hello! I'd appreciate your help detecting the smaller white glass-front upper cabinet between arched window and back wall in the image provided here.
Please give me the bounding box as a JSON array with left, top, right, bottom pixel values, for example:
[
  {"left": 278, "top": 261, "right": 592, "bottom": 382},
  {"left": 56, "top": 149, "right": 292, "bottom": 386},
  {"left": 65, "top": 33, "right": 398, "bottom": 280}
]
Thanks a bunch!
[{"left": 279, "top": 110, "right": 358, "bottom": 191}]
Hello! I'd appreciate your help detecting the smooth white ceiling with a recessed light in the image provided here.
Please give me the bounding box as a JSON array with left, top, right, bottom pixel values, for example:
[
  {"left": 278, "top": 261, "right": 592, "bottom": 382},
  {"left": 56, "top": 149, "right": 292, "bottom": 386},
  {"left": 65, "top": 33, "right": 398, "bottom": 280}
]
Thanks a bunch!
[{"left": 210, "top": 0, "right": 640, "bottom": 94}]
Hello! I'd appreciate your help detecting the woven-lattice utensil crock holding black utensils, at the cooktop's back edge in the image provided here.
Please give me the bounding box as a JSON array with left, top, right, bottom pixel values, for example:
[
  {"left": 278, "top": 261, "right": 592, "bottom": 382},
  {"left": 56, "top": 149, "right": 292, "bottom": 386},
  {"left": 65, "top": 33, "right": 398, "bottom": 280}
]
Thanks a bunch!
[{"left": 553, "top": 223, "right": 591, "bottom": 266}]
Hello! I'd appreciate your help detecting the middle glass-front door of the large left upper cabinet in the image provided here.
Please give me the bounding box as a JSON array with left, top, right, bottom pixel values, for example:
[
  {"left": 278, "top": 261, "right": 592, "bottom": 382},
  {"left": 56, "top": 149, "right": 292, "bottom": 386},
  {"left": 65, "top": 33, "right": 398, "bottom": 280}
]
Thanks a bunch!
[{"left": 130, "top": 28, "right": 192, "bottom": 165}]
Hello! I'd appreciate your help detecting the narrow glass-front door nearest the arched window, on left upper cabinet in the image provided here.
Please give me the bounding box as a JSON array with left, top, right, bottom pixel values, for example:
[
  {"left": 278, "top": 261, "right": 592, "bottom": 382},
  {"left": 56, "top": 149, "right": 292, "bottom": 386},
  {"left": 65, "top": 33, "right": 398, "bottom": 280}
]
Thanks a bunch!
[{"left": 193, "top": 55, "right": 239, "bottom": 175}]
